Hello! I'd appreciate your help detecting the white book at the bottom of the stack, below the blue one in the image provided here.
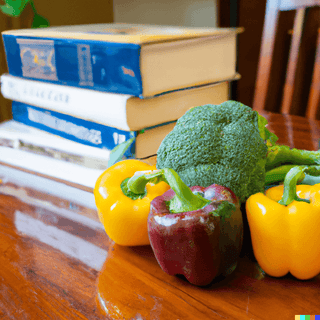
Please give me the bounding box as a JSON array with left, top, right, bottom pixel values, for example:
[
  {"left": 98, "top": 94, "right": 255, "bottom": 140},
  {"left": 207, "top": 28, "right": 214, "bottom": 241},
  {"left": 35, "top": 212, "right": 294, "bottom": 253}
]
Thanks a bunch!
[{"left": 0, "top": 120, "right": 110, "bottom": 189}]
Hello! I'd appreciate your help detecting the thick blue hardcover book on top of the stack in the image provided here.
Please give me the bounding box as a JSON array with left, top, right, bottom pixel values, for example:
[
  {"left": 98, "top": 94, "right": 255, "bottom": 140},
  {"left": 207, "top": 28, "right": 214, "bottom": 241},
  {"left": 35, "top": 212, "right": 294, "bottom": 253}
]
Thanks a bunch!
[{"left": 2, "top": 24, "right": 242, "bottom": 97}]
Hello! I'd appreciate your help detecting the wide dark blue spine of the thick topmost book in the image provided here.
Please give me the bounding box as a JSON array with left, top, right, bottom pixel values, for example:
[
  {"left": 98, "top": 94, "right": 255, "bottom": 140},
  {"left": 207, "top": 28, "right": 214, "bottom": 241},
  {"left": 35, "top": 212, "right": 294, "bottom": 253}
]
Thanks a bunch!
[{"left": 3, "top": 34, "right": 142, "bottom": 96}]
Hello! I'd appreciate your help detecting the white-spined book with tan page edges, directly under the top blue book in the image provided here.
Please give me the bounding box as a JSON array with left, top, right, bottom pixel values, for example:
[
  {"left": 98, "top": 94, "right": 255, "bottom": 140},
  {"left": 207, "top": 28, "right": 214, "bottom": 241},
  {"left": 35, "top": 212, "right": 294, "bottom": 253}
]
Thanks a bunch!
[{"left": 1, "top": 74, "right": 240, "bottom": 131}]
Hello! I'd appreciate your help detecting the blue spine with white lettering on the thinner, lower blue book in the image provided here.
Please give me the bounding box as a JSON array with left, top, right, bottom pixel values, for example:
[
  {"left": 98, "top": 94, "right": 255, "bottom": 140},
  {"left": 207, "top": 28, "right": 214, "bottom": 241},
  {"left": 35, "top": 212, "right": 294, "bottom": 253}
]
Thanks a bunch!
[{"left": 12, "top": 101, "right": 137, "bottom": 158}]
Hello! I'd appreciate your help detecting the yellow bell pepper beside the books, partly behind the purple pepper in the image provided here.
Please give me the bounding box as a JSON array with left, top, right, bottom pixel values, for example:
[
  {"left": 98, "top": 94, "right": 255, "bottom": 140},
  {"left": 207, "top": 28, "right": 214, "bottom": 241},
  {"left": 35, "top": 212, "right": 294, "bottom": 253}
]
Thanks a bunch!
[{"left": 94, "top": 159, "right": 170, "bottom": 246}]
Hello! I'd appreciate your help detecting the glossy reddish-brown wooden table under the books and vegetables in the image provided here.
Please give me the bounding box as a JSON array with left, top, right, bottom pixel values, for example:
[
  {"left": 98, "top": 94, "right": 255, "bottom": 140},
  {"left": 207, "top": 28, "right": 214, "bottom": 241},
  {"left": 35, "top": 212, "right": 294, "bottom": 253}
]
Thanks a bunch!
[{"left": 0, "top": 114, "right": 320, "bottom": 320}]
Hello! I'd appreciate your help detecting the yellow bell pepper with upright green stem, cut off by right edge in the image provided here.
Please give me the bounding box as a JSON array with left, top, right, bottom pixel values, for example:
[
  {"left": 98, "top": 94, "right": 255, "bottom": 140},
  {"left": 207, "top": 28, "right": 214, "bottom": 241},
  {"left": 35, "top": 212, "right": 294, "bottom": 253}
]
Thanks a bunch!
[{"left": 246, "top": 167, "right": 320, "bottom": 279}]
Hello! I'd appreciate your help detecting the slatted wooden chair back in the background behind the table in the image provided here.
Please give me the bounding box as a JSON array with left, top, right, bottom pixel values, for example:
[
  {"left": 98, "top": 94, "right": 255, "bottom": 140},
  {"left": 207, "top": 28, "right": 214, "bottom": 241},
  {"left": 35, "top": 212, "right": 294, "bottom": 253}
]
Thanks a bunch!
[{"left": 253, "top": 0, "right": 320, "bottom": 119}]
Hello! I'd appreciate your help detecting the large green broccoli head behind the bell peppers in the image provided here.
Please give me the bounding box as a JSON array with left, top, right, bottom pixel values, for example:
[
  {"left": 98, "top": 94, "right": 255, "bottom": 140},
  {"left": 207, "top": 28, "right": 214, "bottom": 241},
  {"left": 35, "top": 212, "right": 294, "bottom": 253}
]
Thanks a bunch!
[{"left": 157, "top": 101, "right": 268, "bottom": 202}]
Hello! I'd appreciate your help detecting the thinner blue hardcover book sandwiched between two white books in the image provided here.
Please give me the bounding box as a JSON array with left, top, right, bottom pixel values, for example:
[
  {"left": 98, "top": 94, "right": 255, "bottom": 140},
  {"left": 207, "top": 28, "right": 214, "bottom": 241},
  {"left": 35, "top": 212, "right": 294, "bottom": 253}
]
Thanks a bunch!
[{"left": 12, "top": 101, "right": 176, "bottom": 158}]
